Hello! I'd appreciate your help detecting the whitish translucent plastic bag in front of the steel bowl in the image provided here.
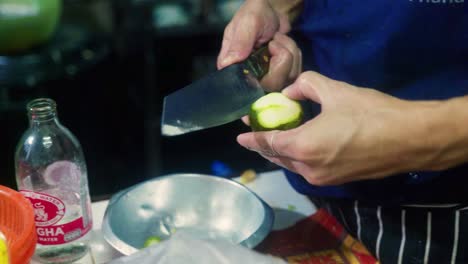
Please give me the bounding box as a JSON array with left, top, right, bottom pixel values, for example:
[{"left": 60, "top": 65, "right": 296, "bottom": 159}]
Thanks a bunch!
[{"left": 110, "top": 233, "right": 286, "bottom": 264}]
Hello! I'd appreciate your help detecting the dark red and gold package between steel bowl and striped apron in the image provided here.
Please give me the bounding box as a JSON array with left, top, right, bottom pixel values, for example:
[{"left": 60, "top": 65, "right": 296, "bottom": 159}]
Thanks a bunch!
[{"left": 256, "top": 209, "right": 379, "bottom": 264}]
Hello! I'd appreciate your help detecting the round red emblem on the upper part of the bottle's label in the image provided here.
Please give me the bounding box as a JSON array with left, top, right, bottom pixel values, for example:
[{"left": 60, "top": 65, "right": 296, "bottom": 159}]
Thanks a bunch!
[{"left": 21, "top": 191, "right": 65, "bottom": 226}]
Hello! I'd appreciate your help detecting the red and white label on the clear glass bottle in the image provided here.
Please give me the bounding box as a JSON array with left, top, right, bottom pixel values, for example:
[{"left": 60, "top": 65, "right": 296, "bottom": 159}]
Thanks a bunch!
[{"left": 21, "top": 190, "right": 92, "bottom": 245}]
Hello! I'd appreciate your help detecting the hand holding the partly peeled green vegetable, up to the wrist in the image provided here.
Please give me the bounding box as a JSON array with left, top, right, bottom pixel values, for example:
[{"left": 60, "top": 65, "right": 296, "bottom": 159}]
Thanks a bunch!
[{"left": 237, "top": 72, "right": 429, "bottom": 185}]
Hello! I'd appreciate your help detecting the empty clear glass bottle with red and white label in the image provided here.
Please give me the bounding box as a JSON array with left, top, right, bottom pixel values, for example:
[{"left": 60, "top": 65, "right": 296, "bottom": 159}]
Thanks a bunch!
[{"left": 15, "top": 98, "right": 92, "bottom": 263}]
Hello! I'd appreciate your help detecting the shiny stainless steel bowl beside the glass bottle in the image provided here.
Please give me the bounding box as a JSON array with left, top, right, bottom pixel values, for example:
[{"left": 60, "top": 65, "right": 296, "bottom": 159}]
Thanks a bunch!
[{"left": 102, "top": 174, "right": 274, "bottom": 255}]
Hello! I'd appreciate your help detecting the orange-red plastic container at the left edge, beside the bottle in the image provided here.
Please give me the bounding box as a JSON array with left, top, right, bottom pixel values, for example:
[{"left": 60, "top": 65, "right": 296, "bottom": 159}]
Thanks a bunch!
[{"left": 0, "top": 185, "right": 37, "bottom": 264}]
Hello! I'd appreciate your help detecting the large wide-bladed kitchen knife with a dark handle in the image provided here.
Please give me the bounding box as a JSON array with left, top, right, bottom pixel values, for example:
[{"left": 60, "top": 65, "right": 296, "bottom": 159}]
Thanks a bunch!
[{"left": 161, "top": 46, "right": 270, "bottom": 136}]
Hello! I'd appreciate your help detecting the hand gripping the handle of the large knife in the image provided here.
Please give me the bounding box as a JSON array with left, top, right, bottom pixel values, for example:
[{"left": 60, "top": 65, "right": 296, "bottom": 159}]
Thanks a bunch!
[{"left": 217, "top": 0, "right": 302, "bottom": 91}]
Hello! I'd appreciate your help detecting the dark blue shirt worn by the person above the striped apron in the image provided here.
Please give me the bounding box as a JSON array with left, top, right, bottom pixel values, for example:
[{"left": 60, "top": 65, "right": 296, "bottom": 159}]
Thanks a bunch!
[{"left": 286, "top": 0, "right": 468, "bottom": 203}]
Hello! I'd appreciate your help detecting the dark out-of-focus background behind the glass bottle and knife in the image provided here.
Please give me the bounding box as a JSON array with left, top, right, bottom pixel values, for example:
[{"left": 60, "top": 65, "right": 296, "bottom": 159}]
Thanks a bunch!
[{"left": 0, "top": 0, "right": 276, "bottom": 200}]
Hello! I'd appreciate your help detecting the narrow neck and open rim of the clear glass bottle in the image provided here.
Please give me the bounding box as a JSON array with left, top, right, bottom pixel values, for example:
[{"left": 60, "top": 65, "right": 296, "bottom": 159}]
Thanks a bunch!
[{"left": 26, "top": 98, "right": 58, "bottom": 126}]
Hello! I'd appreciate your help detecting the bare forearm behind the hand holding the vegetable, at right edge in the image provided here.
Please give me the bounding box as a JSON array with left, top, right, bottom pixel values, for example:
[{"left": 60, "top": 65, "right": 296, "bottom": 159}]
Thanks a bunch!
[{"left": 410, "top": 96, "right": 468, "bottom": 170}]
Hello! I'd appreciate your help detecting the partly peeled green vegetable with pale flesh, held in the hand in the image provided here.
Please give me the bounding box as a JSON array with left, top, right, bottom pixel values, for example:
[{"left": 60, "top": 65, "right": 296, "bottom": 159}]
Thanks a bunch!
[{"left": 249, "top": 92, "right": 303, "bottom": 131}]
